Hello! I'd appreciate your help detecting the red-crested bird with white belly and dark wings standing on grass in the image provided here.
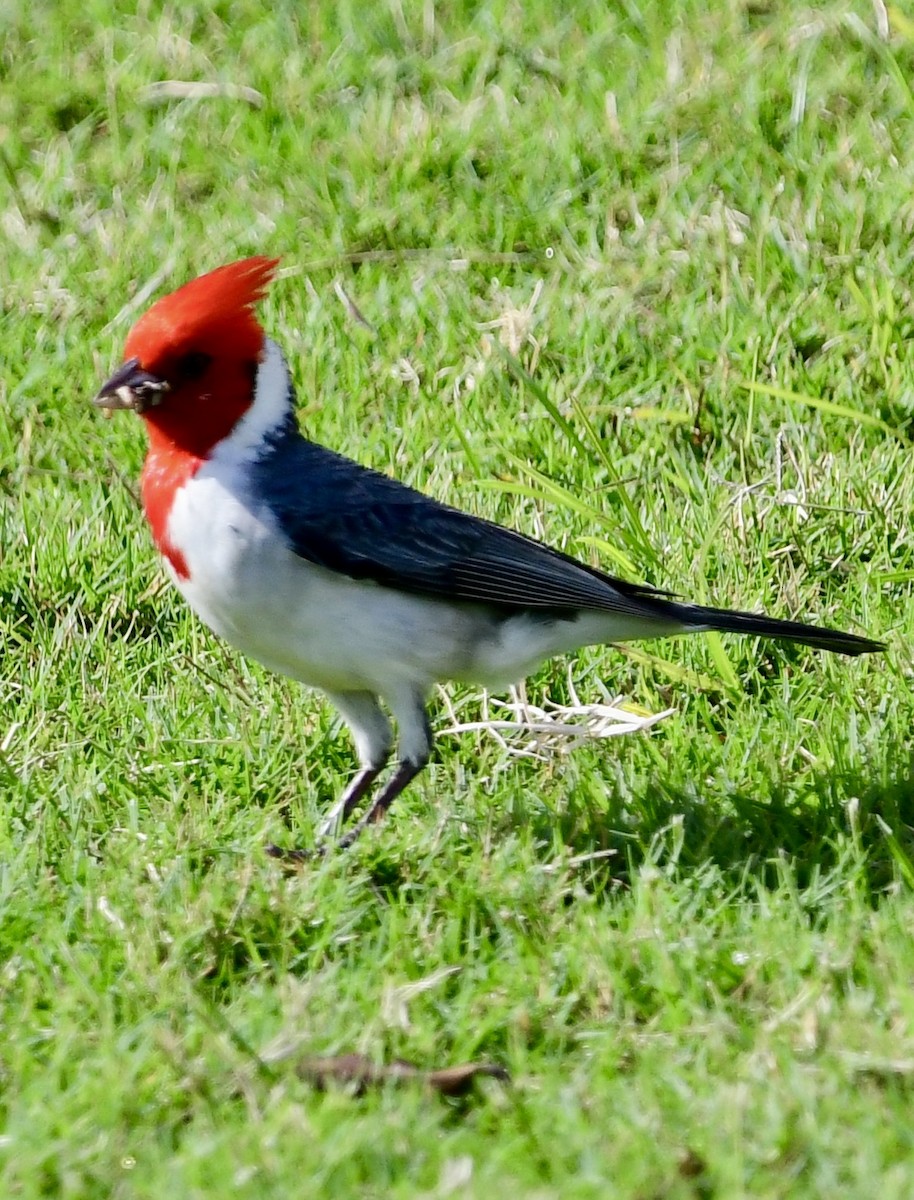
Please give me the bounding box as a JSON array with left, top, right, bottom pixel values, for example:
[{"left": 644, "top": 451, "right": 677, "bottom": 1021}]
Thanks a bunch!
[{"left": 94, "top": 254, "right": 884, "bottom": 862}]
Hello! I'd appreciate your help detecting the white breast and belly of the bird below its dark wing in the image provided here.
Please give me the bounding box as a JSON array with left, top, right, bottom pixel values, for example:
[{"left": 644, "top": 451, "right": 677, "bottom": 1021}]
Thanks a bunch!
[{"left": 168, "top": 467, "right": 501, "bottom": 692}]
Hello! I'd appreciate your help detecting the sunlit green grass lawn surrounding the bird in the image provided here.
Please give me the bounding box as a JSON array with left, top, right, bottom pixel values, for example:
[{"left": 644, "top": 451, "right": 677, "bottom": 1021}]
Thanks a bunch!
[{"left": 0, "top": 0, "right": 914, "bottom": 1200}]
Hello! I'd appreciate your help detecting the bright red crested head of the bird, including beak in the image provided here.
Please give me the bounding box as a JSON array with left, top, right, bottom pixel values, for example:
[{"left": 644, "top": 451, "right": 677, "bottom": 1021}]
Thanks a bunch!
[{"left": 95, "top": 256, "right": 278, "bottom": 458}]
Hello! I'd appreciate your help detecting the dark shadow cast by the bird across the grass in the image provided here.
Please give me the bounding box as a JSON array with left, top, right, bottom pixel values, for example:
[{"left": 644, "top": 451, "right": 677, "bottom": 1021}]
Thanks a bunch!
[{"left": 247, "top": 748, "right": 914, "bottom": 902}]
